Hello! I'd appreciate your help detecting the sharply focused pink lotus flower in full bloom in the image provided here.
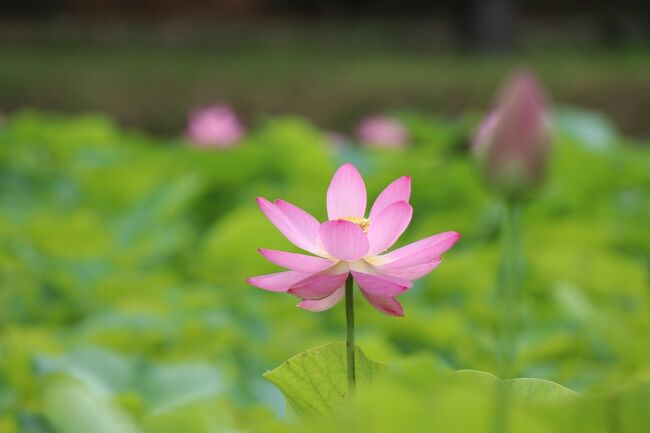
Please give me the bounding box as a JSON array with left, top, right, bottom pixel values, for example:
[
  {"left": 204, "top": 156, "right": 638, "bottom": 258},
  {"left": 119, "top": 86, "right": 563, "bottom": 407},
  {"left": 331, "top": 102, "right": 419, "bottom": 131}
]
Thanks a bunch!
[{"left": 247, "top": 164, "right": 460, "bottom": 316}]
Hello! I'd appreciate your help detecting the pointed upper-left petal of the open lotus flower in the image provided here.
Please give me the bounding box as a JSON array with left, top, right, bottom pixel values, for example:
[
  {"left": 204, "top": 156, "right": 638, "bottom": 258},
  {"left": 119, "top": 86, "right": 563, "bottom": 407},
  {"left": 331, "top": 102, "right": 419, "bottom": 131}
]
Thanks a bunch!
[{"left": 257, "top": 197, "right": 322, "bottom": 254}]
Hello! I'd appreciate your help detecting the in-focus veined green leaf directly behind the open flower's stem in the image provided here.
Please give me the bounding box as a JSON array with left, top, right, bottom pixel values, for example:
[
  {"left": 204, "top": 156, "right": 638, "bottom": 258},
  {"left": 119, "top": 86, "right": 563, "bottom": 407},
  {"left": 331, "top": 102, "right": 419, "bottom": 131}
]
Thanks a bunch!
[{"left": 264, "top": 343, "right": 384, "bottom": 416}]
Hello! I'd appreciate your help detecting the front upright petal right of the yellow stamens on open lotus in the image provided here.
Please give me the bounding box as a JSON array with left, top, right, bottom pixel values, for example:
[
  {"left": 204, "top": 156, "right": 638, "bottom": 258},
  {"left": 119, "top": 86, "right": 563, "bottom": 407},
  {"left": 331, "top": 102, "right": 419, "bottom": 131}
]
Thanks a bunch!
[{"left": 368, "top": 201, "right": 413, "bottom": 256}]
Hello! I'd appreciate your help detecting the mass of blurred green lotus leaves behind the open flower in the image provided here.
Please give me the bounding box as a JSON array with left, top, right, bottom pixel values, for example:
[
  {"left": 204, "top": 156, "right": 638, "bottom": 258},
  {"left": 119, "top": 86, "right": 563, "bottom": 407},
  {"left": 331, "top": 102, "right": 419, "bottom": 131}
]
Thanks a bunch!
[{"left": 0, "top": 109, "right": 650, "bottom": 433}]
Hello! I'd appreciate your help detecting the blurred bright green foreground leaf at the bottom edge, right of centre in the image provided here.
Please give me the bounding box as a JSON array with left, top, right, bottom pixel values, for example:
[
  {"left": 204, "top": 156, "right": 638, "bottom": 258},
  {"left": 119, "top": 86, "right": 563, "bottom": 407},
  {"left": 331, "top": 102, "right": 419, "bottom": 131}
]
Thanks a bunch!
[{"left": 286, "top": 352, "right": 564, "bottom": 433}]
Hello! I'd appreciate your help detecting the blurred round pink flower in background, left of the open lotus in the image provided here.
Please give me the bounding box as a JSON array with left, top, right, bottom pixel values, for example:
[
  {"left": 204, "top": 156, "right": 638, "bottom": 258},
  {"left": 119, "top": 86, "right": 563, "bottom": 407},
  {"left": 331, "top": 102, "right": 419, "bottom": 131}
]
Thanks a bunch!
[{"left": 187, "top": 104, "right": 244, "bottom": 148}]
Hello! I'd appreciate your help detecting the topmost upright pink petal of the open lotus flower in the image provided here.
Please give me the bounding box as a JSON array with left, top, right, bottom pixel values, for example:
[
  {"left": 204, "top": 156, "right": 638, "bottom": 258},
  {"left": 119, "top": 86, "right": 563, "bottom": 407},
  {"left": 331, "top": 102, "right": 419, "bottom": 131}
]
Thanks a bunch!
[{"left": 327, "top": 164, "right": 367, "bottom": 220}]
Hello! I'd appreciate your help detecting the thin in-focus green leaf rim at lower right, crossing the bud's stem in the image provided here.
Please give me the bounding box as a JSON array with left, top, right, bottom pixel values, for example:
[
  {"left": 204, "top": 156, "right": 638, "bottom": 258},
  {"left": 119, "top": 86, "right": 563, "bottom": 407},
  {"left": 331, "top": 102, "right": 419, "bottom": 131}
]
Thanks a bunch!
[{"left": 454, "top": 370, "right": 580, "bottom": 405}]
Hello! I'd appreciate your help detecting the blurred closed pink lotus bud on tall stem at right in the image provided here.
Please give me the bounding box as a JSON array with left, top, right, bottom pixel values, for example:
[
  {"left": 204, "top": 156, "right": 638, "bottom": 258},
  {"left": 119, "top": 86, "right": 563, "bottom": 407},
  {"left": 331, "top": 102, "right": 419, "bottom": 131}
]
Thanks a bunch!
[{"left": 473, "top": 72, "right": 551, "bottom": 196}]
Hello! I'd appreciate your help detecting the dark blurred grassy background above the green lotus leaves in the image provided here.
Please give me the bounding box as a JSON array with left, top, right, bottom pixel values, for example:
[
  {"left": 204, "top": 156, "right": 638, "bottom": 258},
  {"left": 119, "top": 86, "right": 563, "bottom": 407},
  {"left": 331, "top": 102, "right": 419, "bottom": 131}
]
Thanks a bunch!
[{"left": 0, "top": 0, "right": 650, "bottom": 136}]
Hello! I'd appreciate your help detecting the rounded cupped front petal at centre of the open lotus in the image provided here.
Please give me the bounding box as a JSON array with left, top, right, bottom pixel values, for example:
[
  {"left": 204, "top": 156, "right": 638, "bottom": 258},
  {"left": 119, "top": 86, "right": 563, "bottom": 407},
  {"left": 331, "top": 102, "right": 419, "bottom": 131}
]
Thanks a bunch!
[{"left": 319, "top": 220, "right": 368, "bottom": 261}]
